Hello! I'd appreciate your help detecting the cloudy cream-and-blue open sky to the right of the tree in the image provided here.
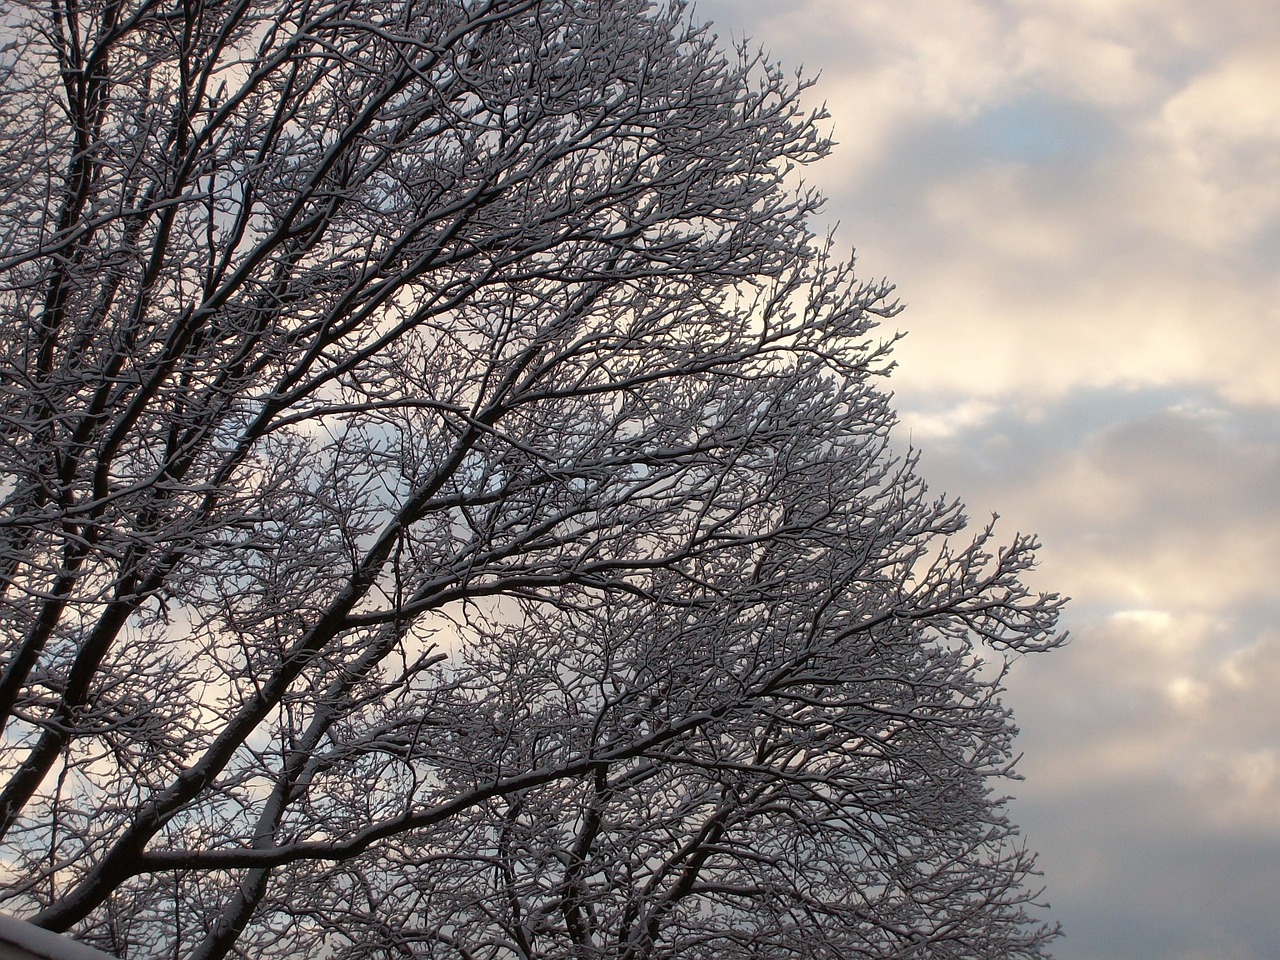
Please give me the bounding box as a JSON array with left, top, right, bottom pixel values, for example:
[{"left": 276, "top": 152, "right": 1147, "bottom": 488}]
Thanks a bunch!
[{"left": 695, "top": 0, "right": 1280, "bottom": 960}]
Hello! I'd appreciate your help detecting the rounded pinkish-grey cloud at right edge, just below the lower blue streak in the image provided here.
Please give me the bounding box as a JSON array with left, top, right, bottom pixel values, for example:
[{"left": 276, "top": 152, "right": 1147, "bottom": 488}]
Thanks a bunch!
[{"left": 1036, "top": 410, "right": 1280, "bottom": 609}]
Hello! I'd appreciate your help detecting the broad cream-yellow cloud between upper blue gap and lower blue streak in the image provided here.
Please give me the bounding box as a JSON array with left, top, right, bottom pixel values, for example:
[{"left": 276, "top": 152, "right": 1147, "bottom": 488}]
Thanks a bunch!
[{"left": 840, "top": 120, "right": 1280, "bottom": 404}]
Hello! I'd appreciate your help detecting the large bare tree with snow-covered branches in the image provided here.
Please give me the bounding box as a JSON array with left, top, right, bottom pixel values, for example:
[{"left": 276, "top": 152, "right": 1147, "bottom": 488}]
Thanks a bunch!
[{"left": 0, "top": 0, "right": 1059, "bottom": 959}]
